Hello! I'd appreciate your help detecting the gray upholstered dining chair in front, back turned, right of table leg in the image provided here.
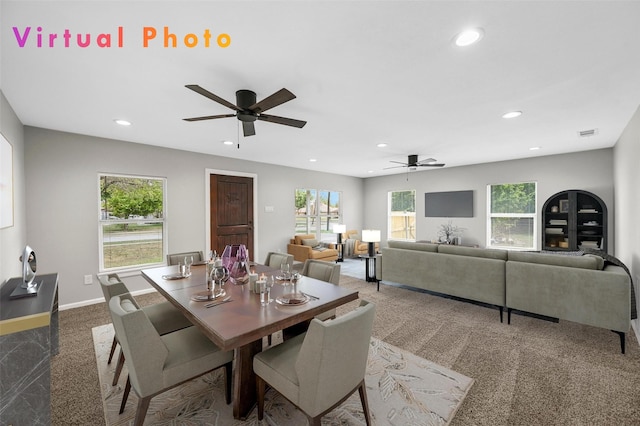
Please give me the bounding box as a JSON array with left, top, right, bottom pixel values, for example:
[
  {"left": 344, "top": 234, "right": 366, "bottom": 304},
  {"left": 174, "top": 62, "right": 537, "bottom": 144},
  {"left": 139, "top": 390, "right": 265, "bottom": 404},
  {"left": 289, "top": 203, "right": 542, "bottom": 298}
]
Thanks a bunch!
[{"left": 253, "top": 300, "right": 375, "bottom": 426}]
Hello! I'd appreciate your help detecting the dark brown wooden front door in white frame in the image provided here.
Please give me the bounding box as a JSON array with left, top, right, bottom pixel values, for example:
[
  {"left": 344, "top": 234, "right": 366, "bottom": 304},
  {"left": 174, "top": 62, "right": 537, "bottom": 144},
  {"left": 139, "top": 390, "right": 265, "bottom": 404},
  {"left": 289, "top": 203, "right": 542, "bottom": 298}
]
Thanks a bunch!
[{"left": 209, "top": 174, "right": 255, "bottom": 256}]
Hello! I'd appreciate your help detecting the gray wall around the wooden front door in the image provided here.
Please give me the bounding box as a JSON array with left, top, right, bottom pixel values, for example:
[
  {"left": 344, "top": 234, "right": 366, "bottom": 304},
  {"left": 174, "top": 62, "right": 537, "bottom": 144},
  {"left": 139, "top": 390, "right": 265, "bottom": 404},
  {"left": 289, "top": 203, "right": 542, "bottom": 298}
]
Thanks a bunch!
[{"left": 25, "top": 127, "right": 363, "bottom": 305}]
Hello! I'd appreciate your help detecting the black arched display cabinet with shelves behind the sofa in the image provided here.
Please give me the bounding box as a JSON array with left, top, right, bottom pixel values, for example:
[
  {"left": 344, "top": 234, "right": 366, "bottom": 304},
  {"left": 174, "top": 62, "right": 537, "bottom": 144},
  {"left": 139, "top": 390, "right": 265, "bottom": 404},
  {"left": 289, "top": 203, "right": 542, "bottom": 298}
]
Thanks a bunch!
[{"left": 542, "top": 189, "right": 607, "bottom": 252}]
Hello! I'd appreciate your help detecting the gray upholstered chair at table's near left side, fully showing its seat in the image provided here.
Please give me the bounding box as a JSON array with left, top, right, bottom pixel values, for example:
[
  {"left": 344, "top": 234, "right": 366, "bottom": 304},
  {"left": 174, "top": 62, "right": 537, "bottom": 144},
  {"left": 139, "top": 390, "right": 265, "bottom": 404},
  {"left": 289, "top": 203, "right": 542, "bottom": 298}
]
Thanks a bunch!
[{"left": 109, "top": 294, "right": 233, "bottom": 425}]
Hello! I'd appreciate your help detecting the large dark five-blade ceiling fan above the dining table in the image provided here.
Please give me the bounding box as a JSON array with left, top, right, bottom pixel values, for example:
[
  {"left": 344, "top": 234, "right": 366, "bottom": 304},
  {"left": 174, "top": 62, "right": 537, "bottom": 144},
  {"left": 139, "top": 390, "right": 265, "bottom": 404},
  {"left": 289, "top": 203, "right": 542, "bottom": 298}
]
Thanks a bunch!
[{"left": 184, "top": 84, "right": 307, "bottom": 136}]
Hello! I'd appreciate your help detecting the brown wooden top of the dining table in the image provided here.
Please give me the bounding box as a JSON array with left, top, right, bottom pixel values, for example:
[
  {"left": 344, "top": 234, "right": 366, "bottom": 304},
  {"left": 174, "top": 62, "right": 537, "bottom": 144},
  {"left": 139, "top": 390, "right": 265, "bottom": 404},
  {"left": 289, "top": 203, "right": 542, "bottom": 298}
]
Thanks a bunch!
[{"left": 142, "top": 264, "right": 358, "bottom": 350}]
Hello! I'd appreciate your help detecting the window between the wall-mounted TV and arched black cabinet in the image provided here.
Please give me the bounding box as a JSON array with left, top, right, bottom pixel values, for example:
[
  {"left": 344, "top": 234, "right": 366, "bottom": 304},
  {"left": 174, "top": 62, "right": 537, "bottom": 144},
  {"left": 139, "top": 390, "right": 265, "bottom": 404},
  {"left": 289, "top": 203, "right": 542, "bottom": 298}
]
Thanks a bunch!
[{"left": 487, "top": 182, "right": 538, "bottom": 250}]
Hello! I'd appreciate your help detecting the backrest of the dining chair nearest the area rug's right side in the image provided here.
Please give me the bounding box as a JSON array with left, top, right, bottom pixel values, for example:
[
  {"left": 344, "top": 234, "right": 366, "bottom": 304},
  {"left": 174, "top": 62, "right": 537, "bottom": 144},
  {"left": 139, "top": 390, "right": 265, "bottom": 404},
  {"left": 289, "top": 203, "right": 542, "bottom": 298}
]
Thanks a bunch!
[{"left": 295, "top": 300, "right": 375, "bottom": 417}]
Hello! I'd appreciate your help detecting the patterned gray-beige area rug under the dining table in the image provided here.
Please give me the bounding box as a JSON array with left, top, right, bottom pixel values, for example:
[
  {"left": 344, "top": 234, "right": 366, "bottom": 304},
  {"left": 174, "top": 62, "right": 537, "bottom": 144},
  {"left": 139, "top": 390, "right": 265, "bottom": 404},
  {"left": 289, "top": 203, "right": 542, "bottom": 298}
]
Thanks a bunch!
[{"left": 92, "top": 324, "right": 473, "bottom": 426}]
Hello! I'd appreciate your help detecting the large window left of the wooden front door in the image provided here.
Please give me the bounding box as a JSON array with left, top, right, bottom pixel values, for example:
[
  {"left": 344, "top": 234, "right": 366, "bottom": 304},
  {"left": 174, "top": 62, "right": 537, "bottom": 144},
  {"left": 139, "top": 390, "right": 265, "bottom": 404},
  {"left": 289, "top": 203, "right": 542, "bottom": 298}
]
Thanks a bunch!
[{"left": 98, "top": 174, "right": 166, "bottom": 271}]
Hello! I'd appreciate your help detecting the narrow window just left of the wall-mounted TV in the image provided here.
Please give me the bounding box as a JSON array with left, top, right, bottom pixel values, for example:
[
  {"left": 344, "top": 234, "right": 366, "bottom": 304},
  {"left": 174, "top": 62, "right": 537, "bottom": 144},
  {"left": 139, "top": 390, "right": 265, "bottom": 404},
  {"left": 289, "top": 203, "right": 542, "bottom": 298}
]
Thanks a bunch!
[{"left": 387, "top": 190, "right": 416, "bottom": 241}]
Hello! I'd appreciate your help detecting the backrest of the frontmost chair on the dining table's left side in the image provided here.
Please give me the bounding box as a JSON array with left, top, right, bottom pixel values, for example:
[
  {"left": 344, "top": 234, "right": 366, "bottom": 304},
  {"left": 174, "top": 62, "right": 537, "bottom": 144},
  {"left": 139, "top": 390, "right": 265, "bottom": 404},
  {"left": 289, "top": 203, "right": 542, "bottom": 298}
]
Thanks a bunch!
[{"left": 109, "top": 293, "right": 169, "bottom": 397}]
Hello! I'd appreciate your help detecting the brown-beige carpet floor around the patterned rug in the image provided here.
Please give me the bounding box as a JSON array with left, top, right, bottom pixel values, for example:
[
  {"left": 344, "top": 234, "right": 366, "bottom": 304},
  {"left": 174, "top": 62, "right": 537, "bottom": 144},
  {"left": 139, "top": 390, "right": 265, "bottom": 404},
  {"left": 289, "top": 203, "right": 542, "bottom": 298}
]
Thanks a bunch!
[{"left": 51, "top": 274, "right": 640, "bottom": 426}]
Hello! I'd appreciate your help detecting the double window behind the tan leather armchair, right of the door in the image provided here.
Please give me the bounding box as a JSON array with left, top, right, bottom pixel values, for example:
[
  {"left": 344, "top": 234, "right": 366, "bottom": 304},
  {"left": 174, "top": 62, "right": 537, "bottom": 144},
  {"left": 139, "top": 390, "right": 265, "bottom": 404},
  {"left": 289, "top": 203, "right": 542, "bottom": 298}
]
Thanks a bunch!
[{"left": 295, "top": 189, "right": 342, "bottom": 241}]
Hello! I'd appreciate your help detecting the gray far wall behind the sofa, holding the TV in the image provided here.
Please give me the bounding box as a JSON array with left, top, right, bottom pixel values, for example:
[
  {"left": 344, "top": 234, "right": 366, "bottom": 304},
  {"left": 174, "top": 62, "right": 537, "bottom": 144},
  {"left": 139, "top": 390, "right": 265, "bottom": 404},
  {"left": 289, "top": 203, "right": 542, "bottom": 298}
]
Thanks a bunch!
[{"left": 364, "top": 149, "right": 615, "bottom": 252}]
